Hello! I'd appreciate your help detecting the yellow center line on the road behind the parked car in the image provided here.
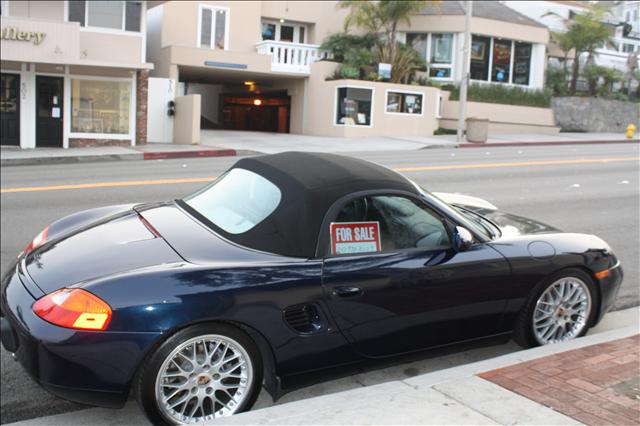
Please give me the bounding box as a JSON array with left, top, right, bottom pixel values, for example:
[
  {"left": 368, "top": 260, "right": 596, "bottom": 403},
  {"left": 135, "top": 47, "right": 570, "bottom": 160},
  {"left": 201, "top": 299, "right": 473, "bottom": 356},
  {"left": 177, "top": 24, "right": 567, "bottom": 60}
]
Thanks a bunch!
[{"left": 0, "top": 157, "right": 640, "bottom": 194}]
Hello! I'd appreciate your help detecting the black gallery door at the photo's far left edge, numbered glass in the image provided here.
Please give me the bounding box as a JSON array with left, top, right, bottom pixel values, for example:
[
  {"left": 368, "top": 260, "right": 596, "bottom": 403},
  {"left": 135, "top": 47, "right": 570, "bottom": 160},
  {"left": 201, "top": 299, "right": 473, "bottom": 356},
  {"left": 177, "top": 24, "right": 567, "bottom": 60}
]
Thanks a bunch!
[{"left": 0, "top": 74, "right": 20, "bottom": 146}]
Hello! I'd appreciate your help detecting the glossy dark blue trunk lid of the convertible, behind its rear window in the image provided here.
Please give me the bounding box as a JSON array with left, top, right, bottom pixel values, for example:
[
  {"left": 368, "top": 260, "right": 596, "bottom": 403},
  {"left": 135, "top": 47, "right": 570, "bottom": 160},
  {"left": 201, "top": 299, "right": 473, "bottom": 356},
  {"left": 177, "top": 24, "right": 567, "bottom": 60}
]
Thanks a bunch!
[{"left": 24, "top": 209, "right": 182, "bottom": 294}]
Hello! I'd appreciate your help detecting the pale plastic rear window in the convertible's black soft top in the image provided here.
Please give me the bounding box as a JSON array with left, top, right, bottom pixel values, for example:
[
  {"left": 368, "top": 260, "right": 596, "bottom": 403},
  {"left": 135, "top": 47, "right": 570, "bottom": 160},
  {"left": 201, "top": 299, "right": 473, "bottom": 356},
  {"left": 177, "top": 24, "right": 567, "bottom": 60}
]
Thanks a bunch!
[{"left": 183, "top": 169, "right": 282, "bottom": 234}]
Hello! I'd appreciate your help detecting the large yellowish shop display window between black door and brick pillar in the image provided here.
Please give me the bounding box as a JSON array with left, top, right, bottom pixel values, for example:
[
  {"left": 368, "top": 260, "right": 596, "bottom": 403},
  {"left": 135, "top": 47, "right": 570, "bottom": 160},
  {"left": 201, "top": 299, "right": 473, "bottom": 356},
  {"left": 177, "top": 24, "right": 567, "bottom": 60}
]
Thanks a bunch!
[{"left": 71, "top": 80, "right": 131, "bottom": 135}]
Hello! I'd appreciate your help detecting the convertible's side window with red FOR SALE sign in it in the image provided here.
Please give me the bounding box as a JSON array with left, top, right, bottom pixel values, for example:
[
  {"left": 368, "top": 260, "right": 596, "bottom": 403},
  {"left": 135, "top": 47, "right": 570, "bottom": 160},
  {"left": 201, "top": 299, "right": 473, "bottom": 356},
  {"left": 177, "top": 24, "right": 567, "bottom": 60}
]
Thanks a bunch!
[{"left": 331, "top": 195, "right": 451, "bottom": 254}]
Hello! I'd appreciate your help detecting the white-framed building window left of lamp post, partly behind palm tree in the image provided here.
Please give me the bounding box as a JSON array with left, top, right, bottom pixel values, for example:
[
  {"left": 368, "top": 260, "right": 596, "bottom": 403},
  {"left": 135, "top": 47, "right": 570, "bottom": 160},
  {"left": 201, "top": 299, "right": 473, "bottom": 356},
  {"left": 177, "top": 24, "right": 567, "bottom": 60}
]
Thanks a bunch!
[{"left": 406, "top": 33, "right": 453, "bottom": 80}]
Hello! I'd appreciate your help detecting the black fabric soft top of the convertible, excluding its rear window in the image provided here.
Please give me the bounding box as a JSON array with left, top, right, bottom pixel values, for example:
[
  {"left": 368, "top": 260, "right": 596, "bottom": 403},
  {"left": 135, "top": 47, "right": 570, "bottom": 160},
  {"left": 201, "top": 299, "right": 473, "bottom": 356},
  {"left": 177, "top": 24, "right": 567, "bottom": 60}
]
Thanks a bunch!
[{"left": 222, "top": 152, "right": 417, "bottom": 257}]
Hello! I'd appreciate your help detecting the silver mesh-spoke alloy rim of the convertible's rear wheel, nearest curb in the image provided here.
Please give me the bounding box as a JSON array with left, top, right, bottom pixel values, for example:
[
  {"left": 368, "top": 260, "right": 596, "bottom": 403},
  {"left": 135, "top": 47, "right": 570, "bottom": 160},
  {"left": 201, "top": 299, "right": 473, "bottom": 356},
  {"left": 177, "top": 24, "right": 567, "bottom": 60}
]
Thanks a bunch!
[{"left": 156, "top": 334, "right": 254, "bottom": 424}]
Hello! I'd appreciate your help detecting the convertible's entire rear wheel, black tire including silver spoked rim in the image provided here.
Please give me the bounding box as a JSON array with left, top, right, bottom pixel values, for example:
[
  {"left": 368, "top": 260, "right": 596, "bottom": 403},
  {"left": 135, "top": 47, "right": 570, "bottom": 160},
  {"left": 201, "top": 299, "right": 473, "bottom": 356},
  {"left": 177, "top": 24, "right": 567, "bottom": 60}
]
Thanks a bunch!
[{"left": 134, "top": 323, "right": 263, "bottom": 425}]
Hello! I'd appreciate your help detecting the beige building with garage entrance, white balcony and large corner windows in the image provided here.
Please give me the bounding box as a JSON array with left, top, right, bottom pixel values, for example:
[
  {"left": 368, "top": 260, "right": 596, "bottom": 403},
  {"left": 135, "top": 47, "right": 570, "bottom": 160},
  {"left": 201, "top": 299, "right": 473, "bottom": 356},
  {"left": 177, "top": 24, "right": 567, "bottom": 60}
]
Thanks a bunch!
[{"left": 147, "top": 1, "right": 555, "bottom": 142}]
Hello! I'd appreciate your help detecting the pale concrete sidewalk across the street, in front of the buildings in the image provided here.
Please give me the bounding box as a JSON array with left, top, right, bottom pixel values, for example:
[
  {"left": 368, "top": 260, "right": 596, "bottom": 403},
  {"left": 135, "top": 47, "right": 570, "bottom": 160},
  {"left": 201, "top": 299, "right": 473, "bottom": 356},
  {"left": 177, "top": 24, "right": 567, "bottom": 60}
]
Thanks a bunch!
[{"left": 0, "top": 130, "right": 639, "bottom": 166}]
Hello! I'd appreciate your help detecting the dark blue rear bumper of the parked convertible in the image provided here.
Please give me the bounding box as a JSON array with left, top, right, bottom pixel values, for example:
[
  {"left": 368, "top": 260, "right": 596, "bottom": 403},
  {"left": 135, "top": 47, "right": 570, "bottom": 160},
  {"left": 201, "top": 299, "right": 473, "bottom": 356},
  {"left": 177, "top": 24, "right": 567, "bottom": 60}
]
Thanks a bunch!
[{"left": 0, "top": 260, "right": 161, "bottom": 408}]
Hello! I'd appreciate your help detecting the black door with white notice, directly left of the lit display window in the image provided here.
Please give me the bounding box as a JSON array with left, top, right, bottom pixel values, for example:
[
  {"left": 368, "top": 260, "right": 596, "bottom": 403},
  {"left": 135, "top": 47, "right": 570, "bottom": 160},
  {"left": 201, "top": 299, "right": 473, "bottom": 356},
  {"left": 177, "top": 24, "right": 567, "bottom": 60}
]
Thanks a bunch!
[{"left": 36, "top": 76, "right": 64, "bottom": 148}]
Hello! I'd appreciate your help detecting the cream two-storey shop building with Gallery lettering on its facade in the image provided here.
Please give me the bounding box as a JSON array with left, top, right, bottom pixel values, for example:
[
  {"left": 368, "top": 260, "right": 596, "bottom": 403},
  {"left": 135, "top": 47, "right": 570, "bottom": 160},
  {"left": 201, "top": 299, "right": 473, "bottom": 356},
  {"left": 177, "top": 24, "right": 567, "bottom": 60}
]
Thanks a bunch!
[{"left": 0, "top": 0, "right": 153, "bottom": 148}]
